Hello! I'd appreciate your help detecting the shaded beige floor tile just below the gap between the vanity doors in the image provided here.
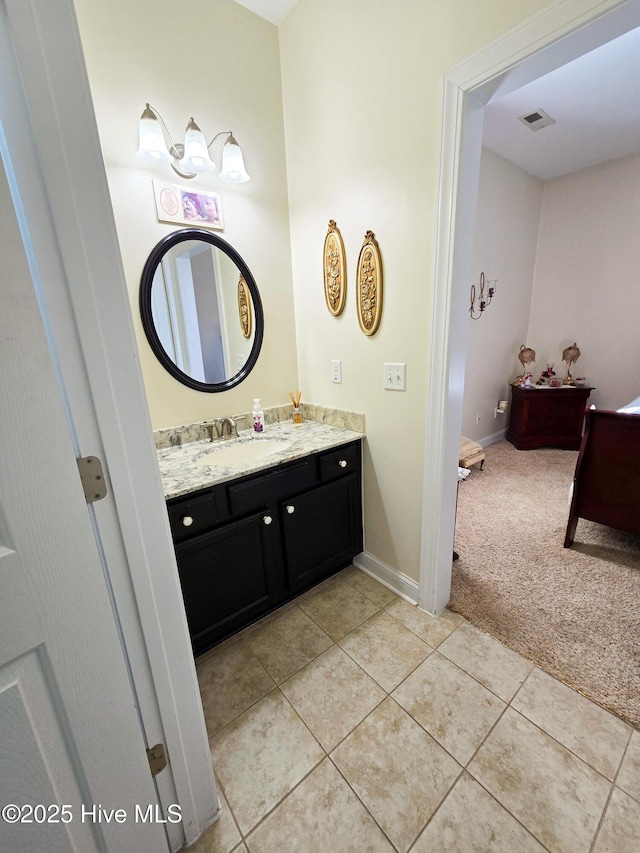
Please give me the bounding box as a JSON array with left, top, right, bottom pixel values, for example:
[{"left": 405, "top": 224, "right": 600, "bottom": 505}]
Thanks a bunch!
[{"left": 246, "top": 607, "right": 333, "bottom": 684}]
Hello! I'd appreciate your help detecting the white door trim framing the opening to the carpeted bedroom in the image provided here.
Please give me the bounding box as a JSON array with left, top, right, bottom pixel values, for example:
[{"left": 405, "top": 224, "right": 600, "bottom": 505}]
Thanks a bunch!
[{"left": 418, "top": 0, "right": 640, "bottom": 614}]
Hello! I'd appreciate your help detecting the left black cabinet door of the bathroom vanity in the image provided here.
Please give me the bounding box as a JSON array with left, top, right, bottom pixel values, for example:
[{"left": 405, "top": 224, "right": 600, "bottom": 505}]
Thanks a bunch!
[{"left": 176, "top": 513, "right": 282, "bottom": 655}]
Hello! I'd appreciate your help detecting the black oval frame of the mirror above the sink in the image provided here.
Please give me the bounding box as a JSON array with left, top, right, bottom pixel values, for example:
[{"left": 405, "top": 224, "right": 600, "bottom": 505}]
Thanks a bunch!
[{"left": 139, "top": 228, "right": 264, "bottom": 394}]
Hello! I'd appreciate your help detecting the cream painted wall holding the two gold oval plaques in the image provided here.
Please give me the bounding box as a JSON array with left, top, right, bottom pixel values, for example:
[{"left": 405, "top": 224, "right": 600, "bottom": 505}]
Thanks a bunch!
[{"left": 280, "top": 0, "right": 545, "bottom": 580}]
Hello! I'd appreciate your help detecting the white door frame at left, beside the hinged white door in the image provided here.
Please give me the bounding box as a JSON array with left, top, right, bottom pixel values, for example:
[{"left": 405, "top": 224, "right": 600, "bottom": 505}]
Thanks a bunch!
[{"left": 6, "top": 0, "right": 219, "bottom": 849}]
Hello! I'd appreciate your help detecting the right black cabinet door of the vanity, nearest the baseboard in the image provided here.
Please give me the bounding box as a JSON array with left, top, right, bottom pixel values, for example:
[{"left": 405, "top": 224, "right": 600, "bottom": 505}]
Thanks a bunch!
[{"left": 280, "top": 474, "right": 362, "bottom": 592}]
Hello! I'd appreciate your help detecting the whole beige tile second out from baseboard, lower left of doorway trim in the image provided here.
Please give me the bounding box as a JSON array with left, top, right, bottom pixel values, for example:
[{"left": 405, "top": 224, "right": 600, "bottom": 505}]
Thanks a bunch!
[{"left": 339, "top": 611, "right": 433, "bottom": 693}]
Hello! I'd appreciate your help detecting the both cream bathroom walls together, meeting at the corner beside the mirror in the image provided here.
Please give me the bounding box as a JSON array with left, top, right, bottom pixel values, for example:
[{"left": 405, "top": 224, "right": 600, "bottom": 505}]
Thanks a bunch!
[{"left": 76, "top": 0, "right": 545, "bottom": 581}]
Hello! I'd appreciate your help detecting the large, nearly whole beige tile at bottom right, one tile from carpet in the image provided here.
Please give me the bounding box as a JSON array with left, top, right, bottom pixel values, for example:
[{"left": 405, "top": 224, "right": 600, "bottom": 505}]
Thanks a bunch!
[{"left": 468, "top": 708, "right": 611, "bottom": 853}]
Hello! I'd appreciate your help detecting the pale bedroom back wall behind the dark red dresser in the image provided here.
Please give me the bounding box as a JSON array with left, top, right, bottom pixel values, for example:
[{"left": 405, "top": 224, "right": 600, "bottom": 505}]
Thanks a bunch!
[{"left": 528, "top": 157, "right": 640, "bottom": 409}]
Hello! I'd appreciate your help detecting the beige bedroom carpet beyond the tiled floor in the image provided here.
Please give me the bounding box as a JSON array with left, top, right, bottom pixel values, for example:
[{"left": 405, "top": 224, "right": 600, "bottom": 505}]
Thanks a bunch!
[{"left": 449, "top": 441, "right": 640, "bottom": 728}]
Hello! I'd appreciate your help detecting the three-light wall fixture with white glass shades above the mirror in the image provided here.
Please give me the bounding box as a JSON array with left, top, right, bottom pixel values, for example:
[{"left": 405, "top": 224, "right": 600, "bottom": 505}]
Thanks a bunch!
[{"left": 136, "top": 104, "right": 251, "bottom": 184}]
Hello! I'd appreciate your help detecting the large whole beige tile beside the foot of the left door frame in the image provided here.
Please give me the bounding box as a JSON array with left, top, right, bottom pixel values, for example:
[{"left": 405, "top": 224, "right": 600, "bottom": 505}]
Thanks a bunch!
[{"left": 211, "top": 690, "right": 324, "bottom": 835}]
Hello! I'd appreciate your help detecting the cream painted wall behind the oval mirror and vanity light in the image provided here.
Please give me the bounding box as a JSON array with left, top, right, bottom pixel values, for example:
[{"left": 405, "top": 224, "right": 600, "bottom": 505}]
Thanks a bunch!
[{"left": 76, "top": 0, "right": 298, "bottom": 429}]
